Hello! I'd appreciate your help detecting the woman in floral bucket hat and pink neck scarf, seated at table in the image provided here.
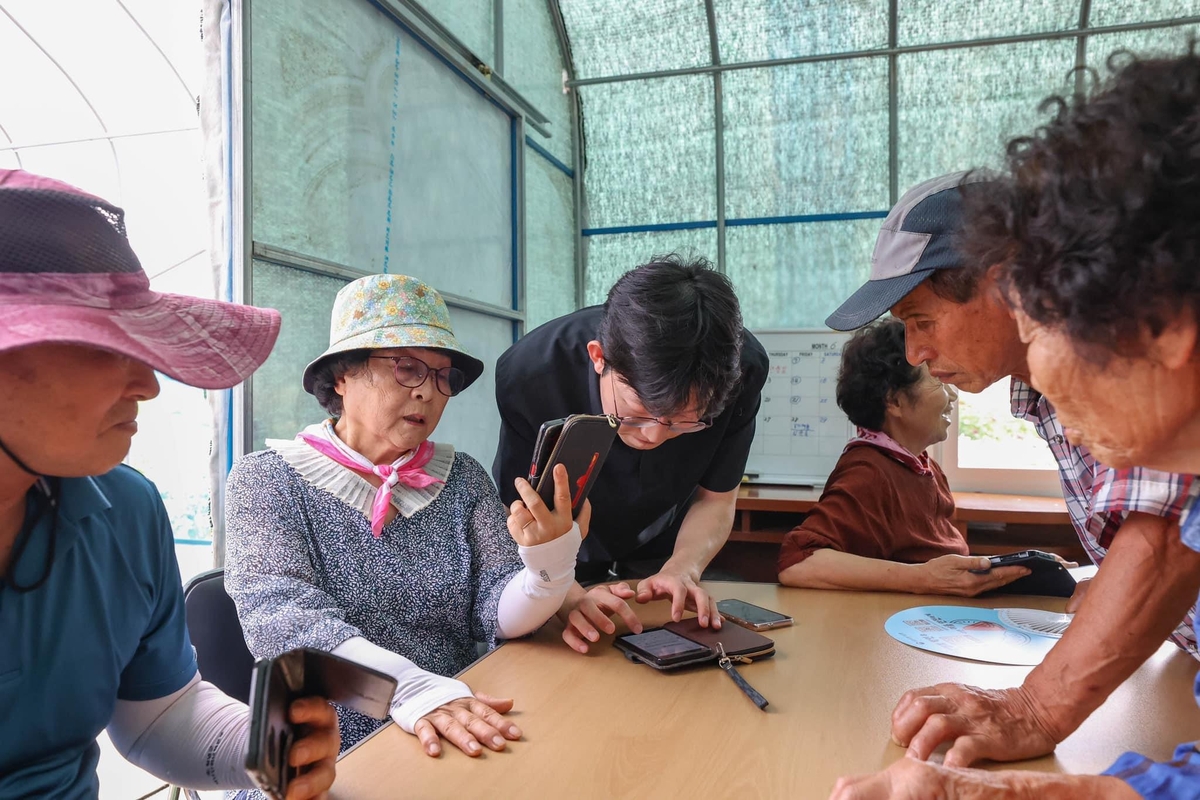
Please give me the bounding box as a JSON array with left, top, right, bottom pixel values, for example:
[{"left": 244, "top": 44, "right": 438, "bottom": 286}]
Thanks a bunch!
[{"left": 226, "top": 275, "right": 590, "bottom": 756}]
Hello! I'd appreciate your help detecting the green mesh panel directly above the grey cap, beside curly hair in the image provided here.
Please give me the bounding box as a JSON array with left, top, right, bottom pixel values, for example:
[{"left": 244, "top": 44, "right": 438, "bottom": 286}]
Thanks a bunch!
[{"left": 898, "top": 40, "right": 1075, "bottom": 192}]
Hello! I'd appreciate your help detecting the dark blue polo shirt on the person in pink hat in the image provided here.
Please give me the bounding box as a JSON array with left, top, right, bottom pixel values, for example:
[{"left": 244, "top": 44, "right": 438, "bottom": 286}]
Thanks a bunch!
[{"left": 0, "top": 467, "right": 196, "bottom": 800}]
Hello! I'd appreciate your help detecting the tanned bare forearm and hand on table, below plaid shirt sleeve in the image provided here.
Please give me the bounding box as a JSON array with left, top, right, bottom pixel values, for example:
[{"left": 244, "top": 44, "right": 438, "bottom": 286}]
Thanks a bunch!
[{"left": 892, "top": 513, "right": 1200, "bottom": 766}]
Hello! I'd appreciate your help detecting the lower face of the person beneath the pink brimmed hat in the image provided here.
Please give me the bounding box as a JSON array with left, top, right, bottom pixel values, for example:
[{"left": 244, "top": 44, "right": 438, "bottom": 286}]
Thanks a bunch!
[{"left": 0, "top": 344, "right": 158, "bottom": 477}]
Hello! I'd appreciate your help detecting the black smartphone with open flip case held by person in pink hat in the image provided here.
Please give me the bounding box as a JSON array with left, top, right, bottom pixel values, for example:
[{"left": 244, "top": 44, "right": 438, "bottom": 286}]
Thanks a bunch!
[{"left": 246, "top": 648, "right": 396, "bottom": 800}]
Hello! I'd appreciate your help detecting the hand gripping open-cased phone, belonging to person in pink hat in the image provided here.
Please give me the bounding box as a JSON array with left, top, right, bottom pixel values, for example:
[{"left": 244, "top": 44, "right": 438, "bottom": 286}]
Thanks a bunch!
[{"left": 246, "top": 648, "right": 396, "bottom": 800}]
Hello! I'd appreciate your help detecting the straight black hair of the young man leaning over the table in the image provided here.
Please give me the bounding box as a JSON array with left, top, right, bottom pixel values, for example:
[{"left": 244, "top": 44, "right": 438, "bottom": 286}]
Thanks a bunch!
[{"left": 598, "top": 254, "right": 743, "bottom": 417}]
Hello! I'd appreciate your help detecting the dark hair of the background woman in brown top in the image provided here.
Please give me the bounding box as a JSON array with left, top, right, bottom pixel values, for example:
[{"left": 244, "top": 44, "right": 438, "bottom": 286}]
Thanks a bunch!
[{"left": 838, "top": 317, "right": 920, "bottom": 431}]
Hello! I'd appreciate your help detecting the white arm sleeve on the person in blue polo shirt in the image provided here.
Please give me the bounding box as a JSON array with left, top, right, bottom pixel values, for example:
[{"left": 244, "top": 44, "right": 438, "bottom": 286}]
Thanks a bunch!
[{"left": 108, "top": 674, "right": 254, "bottom": 789}]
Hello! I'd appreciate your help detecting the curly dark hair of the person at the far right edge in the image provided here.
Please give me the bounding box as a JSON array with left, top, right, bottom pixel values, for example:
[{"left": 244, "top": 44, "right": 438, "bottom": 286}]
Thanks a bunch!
[{"left": 965, "top": 38, "right": 1200, "bottom": 362}]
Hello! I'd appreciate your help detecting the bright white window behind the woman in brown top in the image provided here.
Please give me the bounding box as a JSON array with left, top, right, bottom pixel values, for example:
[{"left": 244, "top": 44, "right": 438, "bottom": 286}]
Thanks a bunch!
[{"left": 958, "top": 380, "right": 1058, "bottom": 469}]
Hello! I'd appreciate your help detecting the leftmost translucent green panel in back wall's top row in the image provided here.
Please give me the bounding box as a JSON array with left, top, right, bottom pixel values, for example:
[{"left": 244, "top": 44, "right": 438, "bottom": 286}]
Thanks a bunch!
[{"left": 559, "top": 0, "right": 713, "bottom": 78}]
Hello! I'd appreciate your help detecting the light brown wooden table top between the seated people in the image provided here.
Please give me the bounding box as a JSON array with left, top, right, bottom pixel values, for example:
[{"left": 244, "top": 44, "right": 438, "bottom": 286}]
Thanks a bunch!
[{"left": 331, "top": 583, "right": 1200, "bottom": 800}]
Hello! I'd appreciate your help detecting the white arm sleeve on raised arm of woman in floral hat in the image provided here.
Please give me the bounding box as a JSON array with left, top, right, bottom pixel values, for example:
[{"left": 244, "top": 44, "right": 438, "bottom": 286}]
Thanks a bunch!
[{"left": 496, "top": 524, "right": 583, "bottom": 639}]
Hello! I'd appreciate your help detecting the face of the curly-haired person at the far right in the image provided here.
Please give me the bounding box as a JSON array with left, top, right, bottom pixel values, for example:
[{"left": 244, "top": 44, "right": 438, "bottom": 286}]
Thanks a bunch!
[{"left": 1016, "top": 304, "right": 1200, "bottom": 471}]
